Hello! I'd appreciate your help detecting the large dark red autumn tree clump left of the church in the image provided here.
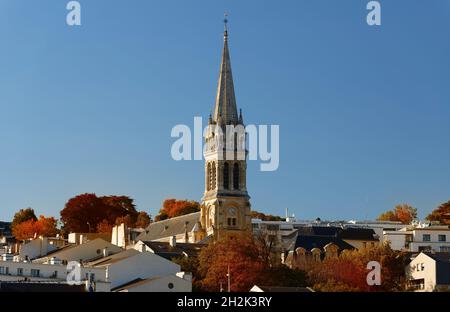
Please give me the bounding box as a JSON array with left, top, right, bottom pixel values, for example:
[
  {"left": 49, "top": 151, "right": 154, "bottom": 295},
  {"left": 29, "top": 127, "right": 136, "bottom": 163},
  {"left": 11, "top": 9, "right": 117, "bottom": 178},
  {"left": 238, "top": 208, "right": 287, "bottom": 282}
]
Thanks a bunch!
[{"left": 61, "top": 194, "right": 138, "bottom": 232}]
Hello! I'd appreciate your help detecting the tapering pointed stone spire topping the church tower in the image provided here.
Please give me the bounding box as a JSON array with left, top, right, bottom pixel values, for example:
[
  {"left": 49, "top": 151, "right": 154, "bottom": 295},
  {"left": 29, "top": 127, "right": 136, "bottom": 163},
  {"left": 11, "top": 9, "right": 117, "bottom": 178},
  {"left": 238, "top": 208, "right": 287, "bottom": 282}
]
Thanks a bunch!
[{"left": 214, "top": 14, "right": 238, "bottom": 124}]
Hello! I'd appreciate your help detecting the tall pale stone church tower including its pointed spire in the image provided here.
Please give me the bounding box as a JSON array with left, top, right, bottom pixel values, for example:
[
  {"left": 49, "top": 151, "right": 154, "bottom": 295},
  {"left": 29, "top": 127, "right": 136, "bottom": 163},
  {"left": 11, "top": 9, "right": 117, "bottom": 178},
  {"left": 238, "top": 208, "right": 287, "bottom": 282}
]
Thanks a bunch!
[{"left": 200, "top": 19, "right": 252, "bottom": 239}]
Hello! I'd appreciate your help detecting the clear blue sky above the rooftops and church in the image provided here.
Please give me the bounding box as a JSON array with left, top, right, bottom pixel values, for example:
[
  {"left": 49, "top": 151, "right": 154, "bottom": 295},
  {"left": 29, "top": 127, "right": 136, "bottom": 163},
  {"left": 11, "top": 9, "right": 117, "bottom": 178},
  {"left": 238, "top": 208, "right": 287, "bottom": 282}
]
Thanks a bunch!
[{"left": 0, "top": 0, "right": 450, "bottom": 220}]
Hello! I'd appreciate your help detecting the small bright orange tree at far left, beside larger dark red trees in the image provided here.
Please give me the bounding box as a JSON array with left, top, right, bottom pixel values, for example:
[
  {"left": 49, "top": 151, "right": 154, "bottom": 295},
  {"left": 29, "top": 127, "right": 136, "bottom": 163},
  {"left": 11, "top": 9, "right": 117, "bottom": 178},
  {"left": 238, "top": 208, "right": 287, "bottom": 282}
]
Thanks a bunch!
[{"left": 13, "top": 216, "right": 58, "bottom": 240}]
